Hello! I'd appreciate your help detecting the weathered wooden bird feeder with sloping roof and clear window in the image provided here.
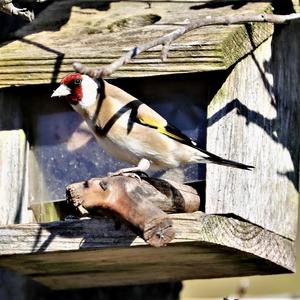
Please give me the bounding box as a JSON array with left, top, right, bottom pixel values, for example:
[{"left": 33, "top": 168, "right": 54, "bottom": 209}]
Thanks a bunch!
[{"left": 0, "top": 0, "right": 300, "bottom": 289}]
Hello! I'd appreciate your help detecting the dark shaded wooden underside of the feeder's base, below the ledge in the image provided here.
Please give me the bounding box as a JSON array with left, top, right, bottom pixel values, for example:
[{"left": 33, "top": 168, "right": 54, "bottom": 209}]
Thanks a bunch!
[{"left": 19, "top": 243, "right": 290, "bottom": 289}]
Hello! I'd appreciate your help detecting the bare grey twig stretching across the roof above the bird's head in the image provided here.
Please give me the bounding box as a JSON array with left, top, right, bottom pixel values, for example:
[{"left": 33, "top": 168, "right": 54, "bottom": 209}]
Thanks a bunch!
[{"left": 73, "top": 13, "right": 300, "bottom": 78}]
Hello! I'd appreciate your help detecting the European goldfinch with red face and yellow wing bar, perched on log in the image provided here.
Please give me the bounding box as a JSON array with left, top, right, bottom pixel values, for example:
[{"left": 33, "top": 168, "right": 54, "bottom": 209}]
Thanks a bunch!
[{"left": 51, "top": 73, "right": 253, "bottom": 174}]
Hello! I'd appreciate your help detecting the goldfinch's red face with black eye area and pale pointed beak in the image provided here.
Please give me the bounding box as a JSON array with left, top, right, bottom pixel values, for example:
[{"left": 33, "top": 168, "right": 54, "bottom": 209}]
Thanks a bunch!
[{"left": 51, "top": 73, "right": 83, "bottom": 105}]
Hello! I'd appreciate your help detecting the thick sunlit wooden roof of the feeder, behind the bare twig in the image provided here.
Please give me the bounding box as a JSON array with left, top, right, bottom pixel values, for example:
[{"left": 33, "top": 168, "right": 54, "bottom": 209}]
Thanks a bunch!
[{"left": 0, "top": 0, "right": 273, "bottom": 87}]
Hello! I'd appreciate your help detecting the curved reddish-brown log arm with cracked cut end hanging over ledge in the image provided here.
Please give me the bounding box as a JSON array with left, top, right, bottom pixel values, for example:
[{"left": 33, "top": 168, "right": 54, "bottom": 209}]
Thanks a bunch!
[{"left": 66, "top": 176, "right": 175, "bottom": 247}]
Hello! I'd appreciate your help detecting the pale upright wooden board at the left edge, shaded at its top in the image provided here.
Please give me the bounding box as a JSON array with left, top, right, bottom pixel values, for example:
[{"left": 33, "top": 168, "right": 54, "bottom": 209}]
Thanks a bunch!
[{"left": 0, "top": 91, "right": 29, "bottom": 225}]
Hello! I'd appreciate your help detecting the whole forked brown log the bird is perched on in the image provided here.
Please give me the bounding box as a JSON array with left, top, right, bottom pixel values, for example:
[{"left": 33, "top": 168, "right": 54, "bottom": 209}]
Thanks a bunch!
[{"left": 67, "top": 176, "right": 200, "bottom": 247}]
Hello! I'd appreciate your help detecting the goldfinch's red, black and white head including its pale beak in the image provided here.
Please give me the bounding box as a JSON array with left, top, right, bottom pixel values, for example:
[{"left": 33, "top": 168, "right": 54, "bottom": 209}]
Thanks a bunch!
[{"left": 51, "top": 73, "right": 98, "bottom": 107}]
